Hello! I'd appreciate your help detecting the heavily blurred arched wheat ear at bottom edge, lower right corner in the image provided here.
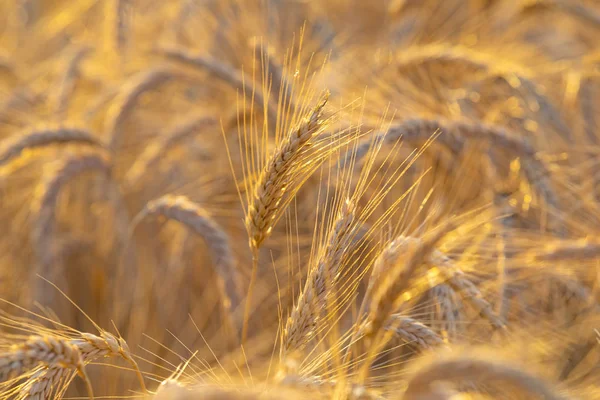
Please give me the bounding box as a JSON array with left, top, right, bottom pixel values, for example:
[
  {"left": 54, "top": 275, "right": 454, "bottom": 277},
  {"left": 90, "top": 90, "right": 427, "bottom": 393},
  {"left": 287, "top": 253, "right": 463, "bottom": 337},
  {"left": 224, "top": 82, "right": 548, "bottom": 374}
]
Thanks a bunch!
[{"left": 402, "top": 351, "right": 566, "bottom": 400}]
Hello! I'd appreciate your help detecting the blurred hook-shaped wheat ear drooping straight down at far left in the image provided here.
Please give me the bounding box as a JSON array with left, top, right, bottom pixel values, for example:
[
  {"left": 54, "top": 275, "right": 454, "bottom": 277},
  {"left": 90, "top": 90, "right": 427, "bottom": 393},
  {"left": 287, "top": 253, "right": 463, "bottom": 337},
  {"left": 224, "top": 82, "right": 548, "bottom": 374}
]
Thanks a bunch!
[{"left": 31, "top": 151, "right": 111, "bottom": 306}]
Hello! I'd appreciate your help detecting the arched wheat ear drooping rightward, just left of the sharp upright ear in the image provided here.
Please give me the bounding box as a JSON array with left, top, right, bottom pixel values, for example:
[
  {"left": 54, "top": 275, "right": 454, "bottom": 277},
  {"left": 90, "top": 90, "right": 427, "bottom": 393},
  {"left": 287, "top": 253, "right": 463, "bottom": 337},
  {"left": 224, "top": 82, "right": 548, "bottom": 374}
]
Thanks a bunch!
[{"left": 133, "top": 195, "right": 242, "bottom": 334}]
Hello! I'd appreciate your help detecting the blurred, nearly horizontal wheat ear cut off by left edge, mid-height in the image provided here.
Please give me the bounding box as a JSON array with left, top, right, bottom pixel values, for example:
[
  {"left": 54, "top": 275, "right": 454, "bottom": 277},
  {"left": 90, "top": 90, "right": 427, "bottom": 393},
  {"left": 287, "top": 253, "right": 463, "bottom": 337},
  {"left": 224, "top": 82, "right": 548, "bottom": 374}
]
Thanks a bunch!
[{"left": 0, "top": 126, "right": 103, "bottom": 166}]
